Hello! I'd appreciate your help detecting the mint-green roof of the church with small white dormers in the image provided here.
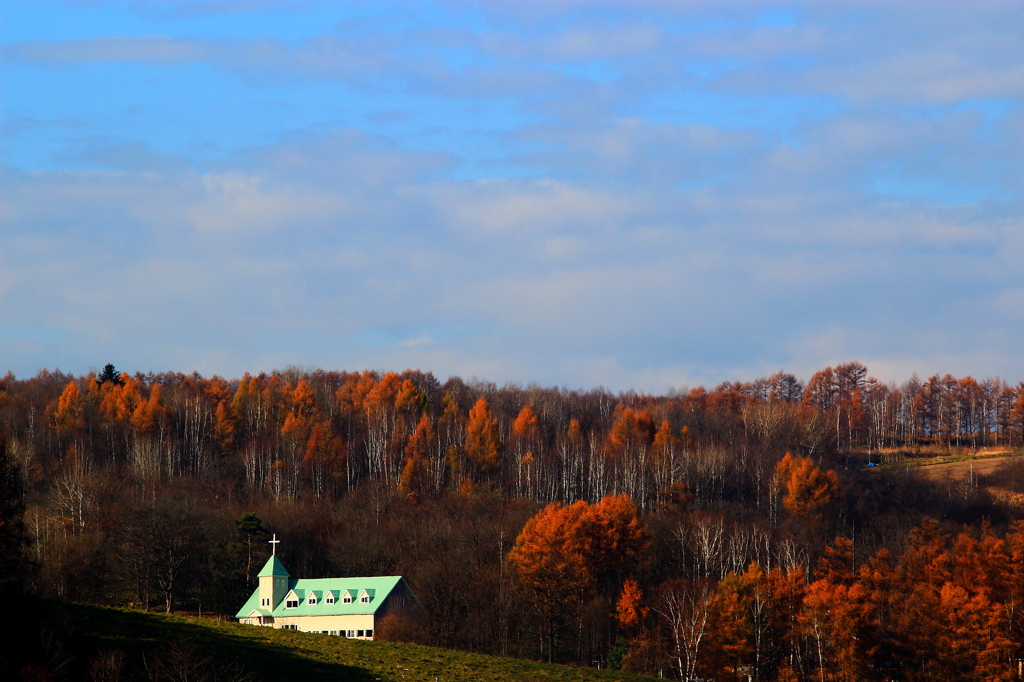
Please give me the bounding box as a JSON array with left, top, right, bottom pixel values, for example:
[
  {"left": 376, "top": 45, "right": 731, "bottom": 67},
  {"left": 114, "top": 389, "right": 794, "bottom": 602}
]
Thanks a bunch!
[{"left": 234, "top": 569, "right": 403, "bottom": 619}]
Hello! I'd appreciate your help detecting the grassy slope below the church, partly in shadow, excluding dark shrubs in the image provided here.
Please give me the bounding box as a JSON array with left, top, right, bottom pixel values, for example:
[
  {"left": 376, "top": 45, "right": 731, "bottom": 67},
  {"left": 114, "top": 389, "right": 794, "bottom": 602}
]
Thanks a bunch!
[{"left": 54, "top": 604, "right": 649, "bottom": 682}]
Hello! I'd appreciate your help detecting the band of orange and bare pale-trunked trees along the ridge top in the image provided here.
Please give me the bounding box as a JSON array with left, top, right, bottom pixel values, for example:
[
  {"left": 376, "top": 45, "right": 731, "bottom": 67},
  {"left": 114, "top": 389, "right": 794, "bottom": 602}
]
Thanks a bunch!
[{"left": 8, "top": 363, "right": 1024, "bottom": 503}]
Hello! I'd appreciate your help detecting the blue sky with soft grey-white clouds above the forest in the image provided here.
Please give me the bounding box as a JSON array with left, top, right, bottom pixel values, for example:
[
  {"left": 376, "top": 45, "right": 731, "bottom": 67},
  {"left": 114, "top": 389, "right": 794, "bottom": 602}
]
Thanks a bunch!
[{"left": 0, "top": 0, "right": 1024, "bottom": 392}]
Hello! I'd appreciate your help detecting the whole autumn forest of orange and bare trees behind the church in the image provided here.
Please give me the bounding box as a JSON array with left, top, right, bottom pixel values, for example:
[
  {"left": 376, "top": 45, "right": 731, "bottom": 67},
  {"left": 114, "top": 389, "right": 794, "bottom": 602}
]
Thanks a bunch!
[{"left": 0, "top": 361, "right": 1024, "bottom": 682}]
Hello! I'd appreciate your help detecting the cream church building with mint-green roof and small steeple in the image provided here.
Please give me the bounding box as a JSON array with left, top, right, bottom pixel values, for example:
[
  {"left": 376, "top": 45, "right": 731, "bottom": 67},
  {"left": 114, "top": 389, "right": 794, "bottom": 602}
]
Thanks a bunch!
[{"left": 234, "top": 539, "right": 421, "bottom": 639}]
